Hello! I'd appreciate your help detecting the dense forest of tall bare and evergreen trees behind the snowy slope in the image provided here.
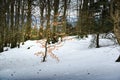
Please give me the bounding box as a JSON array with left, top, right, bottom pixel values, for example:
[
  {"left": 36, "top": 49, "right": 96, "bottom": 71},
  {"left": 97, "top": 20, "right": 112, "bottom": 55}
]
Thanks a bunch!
[{"left": 0, "top": 0, "right": 120, "bottom": 52}]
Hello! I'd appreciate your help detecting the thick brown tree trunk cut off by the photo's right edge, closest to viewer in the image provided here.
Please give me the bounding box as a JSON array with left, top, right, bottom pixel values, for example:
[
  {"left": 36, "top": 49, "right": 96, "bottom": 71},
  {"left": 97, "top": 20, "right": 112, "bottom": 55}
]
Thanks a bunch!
[{"left": 110, "top": 0, "right": 120, "bottom": 62}]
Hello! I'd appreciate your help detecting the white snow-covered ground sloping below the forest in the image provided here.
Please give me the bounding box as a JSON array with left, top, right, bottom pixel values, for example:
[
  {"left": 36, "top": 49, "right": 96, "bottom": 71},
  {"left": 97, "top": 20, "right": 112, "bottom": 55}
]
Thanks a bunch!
[{"left": 0, "top": 37, "right": 120, "bottom": 80}]
